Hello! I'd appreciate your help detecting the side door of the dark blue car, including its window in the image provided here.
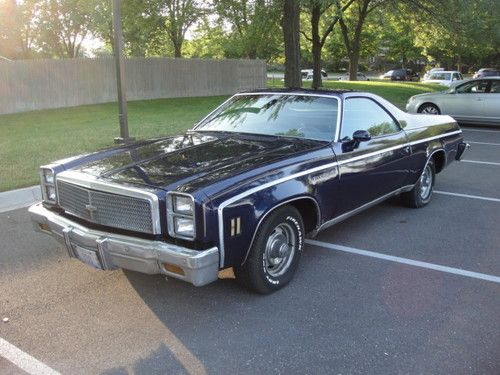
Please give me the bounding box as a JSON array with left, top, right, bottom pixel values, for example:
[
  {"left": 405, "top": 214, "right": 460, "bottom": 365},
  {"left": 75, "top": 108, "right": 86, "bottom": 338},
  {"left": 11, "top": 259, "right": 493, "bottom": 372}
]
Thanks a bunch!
[{"left": 333, "top": 96, "right": 410, "bottom": 216}]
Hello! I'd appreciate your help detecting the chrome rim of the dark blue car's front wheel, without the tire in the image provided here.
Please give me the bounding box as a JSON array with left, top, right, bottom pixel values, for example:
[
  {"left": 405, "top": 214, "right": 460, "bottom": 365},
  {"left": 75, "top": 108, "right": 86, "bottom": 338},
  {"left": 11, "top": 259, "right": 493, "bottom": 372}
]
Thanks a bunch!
[{"left": 264, "top": 223, "right": 297, "bottom": 277}]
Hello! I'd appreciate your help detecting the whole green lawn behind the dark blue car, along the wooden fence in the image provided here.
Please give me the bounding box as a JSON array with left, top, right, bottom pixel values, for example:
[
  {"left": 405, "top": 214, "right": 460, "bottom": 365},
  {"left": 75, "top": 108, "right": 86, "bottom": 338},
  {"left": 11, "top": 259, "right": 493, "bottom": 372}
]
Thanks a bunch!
[{"left": 0, "top": 81, "right": 442, "bottom": 191}]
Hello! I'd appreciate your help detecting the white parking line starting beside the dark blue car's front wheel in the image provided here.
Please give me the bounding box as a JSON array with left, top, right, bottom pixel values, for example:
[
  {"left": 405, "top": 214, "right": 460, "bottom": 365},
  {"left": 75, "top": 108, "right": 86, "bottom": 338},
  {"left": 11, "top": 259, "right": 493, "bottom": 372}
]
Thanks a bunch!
[{"left": 305, "top": 239, "right": 500, "bottom": 284}]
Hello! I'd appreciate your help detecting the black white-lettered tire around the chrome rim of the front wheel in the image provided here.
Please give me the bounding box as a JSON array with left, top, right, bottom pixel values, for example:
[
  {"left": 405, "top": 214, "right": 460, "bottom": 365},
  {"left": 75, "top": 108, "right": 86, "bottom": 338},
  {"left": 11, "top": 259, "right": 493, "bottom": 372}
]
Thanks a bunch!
[{"left": 252, "top": 207, "right": 305, "bottom": 290}]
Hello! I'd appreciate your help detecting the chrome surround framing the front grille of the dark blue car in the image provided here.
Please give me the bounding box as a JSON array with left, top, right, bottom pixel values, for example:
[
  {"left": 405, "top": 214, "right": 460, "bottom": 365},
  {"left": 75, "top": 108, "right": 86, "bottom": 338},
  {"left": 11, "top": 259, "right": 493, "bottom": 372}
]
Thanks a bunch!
[{"left": 56, "top": 171, "right": 161, "bottom": 234}]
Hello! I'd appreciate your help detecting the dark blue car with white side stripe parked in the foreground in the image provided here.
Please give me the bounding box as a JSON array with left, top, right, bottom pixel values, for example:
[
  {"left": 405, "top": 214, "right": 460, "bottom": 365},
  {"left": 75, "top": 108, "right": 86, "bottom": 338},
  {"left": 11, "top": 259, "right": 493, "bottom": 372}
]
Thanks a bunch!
[{"left": 29, "top": 90, "right": 466, "bottom": 293}]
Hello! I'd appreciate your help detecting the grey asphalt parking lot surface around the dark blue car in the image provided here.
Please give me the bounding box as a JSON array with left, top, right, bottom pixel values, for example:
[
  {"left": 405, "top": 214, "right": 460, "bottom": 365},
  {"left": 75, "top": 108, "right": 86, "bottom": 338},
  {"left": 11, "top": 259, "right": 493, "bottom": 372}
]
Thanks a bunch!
[{"left": 0, "top": 128, "right": 500, "bottom": 375}]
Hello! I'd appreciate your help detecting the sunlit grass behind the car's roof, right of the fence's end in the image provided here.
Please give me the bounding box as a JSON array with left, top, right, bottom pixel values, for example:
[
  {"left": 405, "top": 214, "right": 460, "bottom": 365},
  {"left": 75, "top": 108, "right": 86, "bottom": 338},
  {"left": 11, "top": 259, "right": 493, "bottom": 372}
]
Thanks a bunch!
[{"left": 268, "top": 79, "right": 445, "bottom": 109}]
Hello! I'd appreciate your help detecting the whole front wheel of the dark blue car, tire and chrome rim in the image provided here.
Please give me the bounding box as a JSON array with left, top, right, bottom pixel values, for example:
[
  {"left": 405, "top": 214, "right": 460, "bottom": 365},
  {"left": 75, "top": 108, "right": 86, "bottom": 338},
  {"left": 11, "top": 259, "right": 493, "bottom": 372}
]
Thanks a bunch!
[{"left": 234, "top": 206, "right": 304, "bottom": 294}]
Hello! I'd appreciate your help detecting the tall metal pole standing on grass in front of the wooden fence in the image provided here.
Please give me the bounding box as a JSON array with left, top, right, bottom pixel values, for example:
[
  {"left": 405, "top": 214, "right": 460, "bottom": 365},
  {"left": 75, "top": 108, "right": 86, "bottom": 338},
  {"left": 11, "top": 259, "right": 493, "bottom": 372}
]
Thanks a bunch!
[{"left": 113, "top": 0, "right": 133, "bottom": 143}]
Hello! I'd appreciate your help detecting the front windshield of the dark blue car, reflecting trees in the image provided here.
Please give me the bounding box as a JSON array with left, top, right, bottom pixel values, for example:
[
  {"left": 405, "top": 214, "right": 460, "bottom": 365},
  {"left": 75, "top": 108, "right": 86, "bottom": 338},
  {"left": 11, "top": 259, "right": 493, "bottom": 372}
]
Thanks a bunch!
[{"left": 196, "top": 93, "right": 338, "bottom": 141}]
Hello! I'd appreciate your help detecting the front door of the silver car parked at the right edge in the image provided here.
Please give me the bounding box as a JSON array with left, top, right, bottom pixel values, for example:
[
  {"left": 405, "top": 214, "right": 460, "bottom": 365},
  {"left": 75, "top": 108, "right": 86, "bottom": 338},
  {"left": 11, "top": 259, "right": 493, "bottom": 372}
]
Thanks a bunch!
[{"left": 440, "top": 80, "right": 488, "bottom": 121}]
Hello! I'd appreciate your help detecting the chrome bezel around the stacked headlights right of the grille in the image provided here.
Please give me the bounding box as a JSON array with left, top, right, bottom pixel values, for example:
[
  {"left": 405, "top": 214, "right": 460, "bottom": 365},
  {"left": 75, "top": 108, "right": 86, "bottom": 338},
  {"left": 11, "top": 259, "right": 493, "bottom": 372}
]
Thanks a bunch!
[{"left": 166, "top": 192, "right": 196, "bottom": 241}]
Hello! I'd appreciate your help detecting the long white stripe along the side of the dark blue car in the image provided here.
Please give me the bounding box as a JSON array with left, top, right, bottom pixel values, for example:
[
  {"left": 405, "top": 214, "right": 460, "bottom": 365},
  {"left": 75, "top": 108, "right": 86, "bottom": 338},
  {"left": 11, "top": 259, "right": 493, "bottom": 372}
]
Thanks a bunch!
[{"left": 217, "top": 130, "right": 462, "bottom": 268}]
